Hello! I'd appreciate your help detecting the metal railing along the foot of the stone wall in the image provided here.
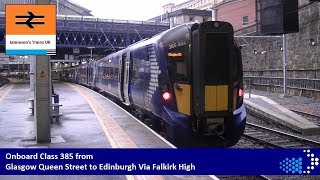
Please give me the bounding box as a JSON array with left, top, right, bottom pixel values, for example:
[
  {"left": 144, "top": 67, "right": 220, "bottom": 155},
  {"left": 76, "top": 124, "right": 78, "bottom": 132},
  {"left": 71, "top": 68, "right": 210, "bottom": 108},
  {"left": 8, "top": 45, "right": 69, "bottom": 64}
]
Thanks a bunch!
[{"left": 243, "top": 76, "right": 320, "bottom": 92}]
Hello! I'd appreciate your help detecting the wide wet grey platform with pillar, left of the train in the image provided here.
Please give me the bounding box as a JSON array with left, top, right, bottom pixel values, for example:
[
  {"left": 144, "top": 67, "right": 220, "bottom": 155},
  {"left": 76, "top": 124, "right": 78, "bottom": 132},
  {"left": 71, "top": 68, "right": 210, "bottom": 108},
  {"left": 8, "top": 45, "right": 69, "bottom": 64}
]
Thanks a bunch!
[{"left": 0, "top": 83, "right": 217, "bottom": 180}]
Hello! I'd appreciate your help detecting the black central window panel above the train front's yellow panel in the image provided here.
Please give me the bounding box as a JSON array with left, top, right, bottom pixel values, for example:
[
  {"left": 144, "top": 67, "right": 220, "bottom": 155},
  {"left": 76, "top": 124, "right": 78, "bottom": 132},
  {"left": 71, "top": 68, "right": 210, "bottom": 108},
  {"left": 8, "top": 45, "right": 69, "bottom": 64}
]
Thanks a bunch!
[{"left": 205, "top": 33, "right": 231, "bottom": 85}]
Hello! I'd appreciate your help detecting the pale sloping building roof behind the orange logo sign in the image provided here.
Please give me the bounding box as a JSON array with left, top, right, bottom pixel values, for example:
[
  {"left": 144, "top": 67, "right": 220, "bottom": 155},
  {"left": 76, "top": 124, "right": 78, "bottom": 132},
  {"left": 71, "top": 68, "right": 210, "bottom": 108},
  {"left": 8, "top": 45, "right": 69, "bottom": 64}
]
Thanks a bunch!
[{"left": 0, "top": 0, "right": 93, "bottom": 16}]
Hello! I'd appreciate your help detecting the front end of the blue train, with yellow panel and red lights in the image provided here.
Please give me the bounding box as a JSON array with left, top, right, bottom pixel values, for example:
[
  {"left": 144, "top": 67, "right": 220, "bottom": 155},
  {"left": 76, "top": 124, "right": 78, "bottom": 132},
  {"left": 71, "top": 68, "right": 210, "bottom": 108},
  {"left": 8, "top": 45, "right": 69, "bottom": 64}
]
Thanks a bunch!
[{"left": 162, "top": 21, "right": 246, "bottom": 147}]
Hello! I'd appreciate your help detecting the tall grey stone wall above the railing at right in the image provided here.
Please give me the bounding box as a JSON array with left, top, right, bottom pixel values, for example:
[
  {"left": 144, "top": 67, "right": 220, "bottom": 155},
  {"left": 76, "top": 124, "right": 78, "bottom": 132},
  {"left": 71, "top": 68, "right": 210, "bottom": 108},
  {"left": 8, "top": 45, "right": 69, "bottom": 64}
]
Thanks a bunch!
[{"left": 235, "top": 0, "right": 320, "bottom": 79}]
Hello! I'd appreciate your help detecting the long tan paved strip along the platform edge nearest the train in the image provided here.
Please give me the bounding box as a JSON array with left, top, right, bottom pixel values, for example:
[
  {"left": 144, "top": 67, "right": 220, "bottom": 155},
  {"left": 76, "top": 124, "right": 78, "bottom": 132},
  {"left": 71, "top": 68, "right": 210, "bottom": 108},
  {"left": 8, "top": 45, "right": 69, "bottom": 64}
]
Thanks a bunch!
[{"left": 68, "top": 83, "right": 164, "bottom": 180}]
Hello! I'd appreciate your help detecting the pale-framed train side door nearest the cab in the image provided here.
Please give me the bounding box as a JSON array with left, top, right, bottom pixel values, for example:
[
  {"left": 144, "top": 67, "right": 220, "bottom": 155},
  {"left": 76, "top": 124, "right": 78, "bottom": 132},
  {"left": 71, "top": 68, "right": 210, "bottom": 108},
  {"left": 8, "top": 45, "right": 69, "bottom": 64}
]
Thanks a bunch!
[{"left": 123, "top": 52, "right": 130, "bottom": 105}]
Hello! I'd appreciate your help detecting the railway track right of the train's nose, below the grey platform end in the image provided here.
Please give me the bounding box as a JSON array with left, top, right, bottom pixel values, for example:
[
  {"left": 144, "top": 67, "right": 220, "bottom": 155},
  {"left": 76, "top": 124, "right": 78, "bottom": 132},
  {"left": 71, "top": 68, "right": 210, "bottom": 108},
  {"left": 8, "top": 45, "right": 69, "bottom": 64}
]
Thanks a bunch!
[{"left": 243, "top": 123, "right": 320, "bottom": 148}]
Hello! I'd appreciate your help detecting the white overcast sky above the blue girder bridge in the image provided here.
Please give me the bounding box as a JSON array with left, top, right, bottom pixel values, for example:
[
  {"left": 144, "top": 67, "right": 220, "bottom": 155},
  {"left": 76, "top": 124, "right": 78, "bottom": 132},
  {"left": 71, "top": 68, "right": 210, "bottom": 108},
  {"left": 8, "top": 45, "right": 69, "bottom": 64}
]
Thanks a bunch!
[{"left": 71, "top": 0, "right": 187, "bottom": 21}]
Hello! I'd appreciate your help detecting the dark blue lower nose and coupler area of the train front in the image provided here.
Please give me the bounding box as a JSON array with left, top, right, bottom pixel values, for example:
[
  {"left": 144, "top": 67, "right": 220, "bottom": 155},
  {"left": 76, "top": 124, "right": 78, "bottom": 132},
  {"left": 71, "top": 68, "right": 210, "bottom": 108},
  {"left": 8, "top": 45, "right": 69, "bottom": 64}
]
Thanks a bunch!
[{"left": 160, "top": 106, "right": 246, "bottom": 147}]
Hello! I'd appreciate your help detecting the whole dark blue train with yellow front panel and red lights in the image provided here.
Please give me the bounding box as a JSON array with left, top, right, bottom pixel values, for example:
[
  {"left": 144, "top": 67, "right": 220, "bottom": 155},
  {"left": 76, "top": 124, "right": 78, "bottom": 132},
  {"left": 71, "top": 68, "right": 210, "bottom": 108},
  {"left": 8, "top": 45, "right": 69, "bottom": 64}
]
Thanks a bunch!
[{"left": 58, "top": 21, "right": 246, "bottom": 147}]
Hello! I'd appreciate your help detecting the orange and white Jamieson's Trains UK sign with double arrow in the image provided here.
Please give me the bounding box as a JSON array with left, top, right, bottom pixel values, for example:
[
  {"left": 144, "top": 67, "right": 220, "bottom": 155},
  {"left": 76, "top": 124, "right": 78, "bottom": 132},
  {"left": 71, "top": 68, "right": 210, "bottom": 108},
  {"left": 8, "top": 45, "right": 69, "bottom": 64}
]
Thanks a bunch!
[{"left": 5, "top": 4, "right": 57, "bottom": 56}]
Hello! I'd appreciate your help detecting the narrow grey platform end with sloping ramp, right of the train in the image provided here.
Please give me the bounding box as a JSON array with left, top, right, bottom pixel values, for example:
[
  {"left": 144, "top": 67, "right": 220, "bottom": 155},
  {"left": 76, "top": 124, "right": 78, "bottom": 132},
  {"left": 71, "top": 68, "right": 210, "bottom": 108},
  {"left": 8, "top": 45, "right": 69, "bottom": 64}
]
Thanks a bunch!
[{"left": 244, "top": 93, "right": 320, "bottom": 135}]
